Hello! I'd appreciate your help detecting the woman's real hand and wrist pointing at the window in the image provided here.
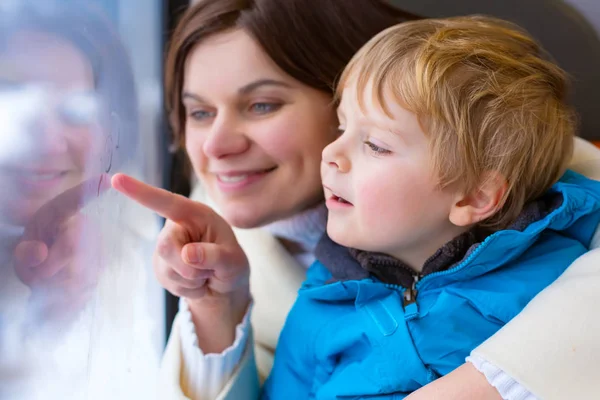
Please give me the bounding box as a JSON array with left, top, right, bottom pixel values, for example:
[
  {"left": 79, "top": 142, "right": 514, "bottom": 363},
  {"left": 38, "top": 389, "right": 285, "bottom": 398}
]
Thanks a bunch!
[{"left": 112, "top": 174, "right": 250, "bottom": 353}]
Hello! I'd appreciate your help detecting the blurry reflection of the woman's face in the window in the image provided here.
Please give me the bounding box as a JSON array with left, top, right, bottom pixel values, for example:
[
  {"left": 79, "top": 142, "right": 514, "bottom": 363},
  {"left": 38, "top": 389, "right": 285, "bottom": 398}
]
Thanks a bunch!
[{"left": 0, "top": 31, "right": 101, "bottom": 224}]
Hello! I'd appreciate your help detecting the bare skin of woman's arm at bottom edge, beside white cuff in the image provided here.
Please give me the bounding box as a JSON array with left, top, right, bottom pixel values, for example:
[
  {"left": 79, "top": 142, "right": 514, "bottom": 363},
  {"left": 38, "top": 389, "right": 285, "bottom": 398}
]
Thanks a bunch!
[{"left": 406, "top": 362, "right": 502, "bottom": 400}]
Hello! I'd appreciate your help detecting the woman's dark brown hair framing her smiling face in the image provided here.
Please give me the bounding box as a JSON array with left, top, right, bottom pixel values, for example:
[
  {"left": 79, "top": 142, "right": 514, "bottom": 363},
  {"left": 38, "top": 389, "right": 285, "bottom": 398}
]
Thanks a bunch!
[{"left": 165, "top": 0, "right": 418, "bottom": 147}]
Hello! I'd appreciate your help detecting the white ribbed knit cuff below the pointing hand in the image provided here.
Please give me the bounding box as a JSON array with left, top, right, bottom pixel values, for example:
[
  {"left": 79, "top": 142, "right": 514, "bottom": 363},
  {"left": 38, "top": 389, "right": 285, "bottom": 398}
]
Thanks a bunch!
[{"left": 179, "top": 299, "right": 252, "bottom": 400}]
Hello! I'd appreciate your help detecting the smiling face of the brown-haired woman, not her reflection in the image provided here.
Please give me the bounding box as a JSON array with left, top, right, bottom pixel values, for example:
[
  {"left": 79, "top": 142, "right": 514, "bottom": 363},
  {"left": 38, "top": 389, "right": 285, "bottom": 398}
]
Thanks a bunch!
[{"left": 181, "top": 30, "right": 337, "bottom": 228}]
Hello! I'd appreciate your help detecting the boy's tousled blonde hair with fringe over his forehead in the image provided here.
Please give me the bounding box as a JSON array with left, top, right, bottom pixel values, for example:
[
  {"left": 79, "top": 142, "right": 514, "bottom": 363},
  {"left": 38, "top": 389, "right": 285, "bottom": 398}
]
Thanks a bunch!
[{"left": 337, "top": 16, "right": 576, "bottom": 229}]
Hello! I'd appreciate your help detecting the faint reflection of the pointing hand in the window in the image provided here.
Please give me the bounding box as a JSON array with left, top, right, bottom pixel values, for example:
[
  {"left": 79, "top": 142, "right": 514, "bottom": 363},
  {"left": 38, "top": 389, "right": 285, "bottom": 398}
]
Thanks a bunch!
[{"left": 13, "top": 175, "right": 110, "bottom": 327}]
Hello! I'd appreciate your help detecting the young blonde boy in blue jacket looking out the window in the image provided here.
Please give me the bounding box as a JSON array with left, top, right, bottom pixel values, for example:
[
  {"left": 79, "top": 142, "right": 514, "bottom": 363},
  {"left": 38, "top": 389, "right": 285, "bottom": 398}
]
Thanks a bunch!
[{"left": 264, "top": 17, "right": 600, "bottom": 399}]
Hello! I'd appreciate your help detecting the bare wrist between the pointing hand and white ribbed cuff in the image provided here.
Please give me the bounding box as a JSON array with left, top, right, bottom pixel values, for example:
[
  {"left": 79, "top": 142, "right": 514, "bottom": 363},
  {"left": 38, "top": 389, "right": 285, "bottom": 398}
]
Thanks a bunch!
[{"left": 186, "top": 286, "right": 250, "bottom": 354}]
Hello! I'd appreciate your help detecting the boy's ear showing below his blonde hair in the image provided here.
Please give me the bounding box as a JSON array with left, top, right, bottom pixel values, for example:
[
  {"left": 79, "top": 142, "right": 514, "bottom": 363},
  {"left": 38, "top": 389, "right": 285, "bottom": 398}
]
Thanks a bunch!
[{"left": 450, "top": 172, "right": 508, "bottom": 226}]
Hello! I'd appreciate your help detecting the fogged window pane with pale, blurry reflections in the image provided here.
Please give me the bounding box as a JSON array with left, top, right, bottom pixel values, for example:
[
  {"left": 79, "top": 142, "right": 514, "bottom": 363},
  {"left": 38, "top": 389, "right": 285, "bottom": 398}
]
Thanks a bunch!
[{"left": 0, "top": 0, "right": 164, "bottom": 400}]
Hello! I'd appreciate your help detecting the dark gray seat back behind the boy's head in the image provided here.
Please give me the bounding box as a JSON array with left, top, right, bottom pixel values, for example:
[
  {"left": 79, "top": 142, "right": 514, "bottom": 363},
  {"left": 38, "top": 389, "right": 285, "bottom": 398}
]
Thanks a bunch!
[{"left": 391, "top": 0, "right": 600, "bottom": 140}]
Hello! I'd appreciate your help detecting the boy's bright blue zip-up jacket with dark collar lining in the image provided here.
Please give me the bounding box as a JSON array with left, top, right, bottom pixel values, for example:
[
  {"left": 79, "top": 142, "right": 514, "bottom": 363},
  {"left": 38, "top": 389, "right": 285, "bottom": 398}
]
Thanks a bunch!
[{"left": 263, "top": 171, "right": 600, "bottom": 400}]
